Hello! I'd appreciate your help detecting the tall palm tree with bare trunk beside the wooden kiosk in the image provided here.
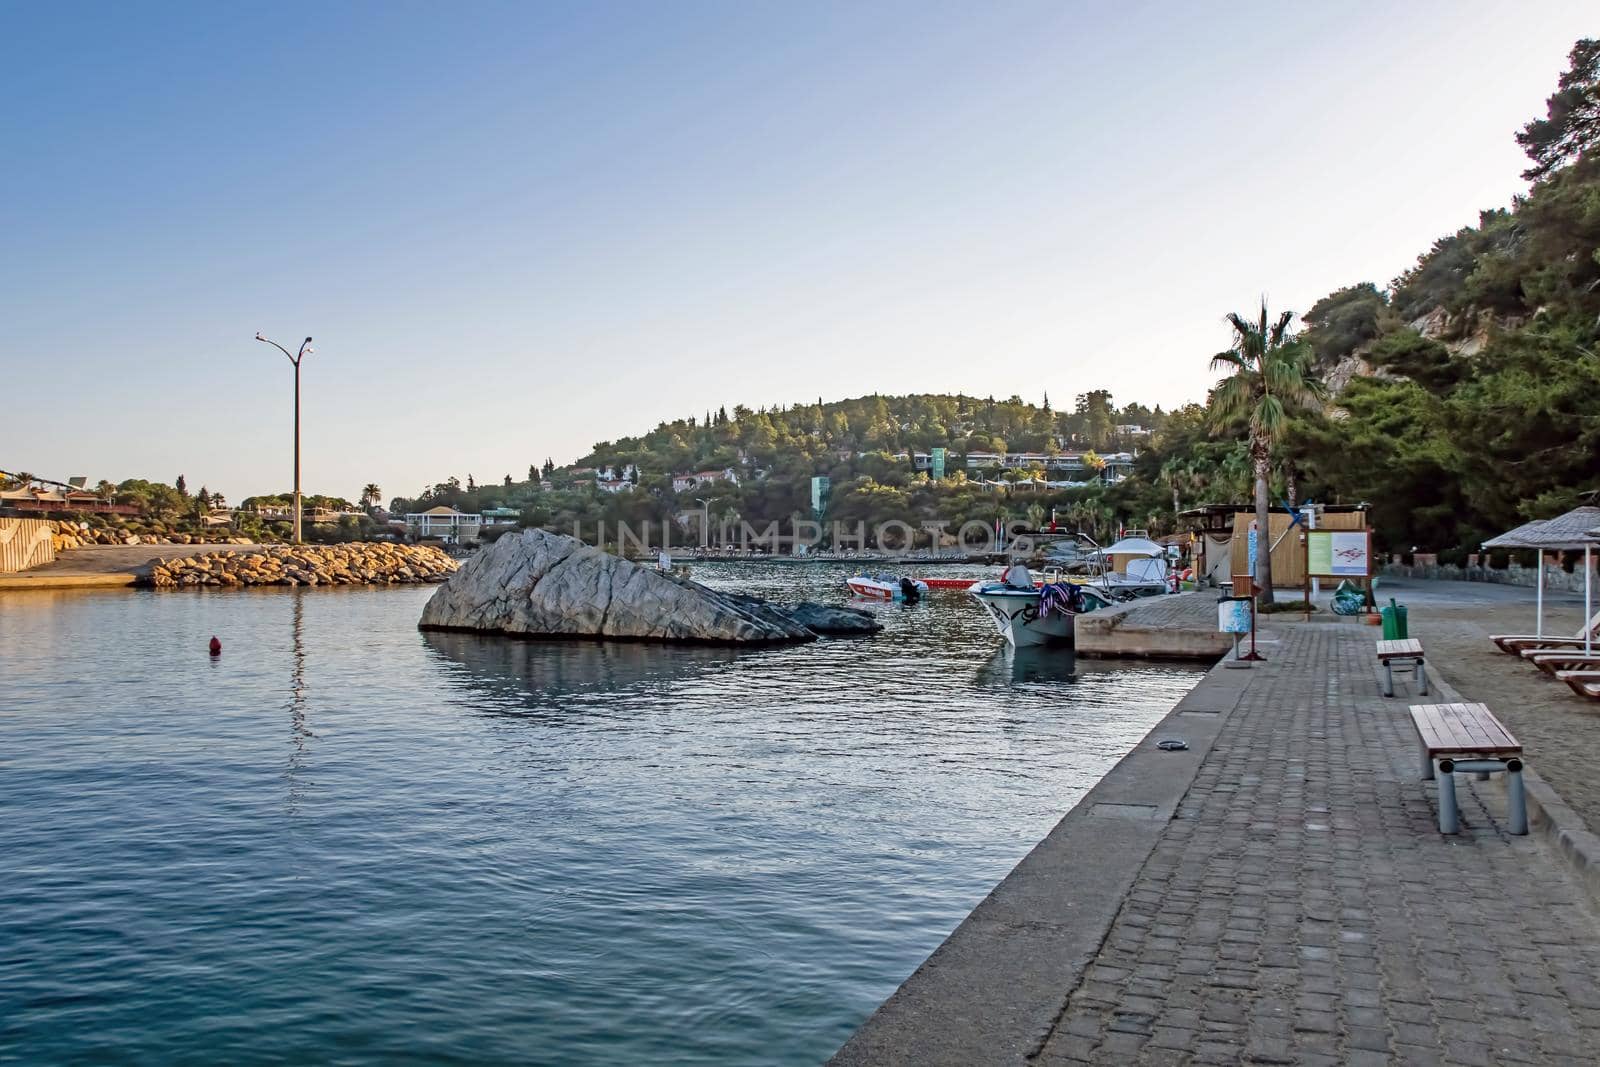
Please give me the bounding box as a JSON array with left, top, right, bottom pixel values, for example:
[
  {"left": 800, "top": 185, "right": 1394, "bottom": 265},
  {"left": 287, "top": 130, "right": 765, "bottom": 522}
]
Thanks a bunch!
[{"left": 1211, "top": 301, "right": 1326, "bottom": 605}]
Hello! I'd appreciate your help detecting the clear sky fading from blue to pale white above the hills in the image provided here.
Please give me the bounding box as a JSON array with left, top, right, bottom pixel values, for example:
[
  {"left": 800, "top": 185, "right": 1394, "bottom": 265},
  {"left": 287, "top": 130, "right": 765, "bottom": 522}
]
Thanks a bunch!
[{"left": 0, "top": 0, "right": 1600, "bottom": 502}]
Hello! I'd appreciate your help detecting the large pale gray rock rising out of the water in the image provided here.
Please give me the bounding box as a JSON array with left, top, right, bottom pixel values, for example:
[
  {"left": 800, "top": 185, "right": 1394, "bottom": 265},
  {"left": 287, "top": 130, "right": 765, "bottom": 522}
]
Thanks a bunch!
[{"left": 418, "top": 530, "right": 816, "bottom": 645}]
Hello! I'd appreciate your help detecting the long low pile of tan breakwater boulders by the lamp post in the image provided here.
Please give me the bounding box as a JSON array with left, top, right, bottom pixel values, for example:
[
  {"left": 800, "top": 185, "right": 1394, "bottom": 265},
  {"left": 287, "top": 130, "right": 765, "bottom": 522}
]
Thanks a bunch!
[{"left": 149, "top": 542, "right": 459, "bottom": 587}]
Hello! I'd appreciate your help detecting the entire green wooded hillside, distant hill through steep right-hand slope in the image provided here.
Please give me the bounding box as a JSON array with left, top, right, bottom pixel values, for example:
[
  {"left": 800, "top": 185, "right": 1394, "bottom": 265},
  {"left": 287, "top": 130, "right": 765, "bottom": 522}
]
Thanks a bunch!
[{"left": 395, "top": 40, "right": 1600, "bottom": 558}]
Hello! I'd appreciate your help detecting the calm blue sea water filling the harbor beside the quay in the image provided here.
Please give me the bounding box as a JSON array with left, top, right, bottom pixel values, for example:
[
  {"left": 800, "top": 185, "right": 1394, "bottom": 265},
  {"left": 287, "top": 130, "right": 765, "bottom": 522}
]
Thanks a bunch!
[{"left": 0, "top": 565, "right": 1198, "bottom": 1064}]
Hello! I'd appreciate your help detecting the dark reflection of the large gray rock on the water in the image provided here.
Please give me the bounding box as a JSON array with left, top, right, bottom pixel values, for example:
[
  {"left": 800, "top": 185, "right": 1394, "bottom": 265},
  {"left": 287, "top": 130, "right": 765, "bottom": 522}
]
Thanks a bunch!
[{"left": 422, "top": 630, "right": 748, "bottom": 712}]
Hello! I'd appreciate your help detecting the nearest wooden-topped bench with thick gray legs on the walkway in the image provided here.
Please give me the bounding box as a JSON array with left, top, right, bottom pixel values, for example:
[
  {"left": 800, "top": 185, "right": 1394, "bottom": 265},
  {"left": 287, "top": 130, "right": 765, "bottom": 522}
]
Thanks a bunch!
[{"left": 1411, "top": 704, "right": 1528, "bottom": 833}]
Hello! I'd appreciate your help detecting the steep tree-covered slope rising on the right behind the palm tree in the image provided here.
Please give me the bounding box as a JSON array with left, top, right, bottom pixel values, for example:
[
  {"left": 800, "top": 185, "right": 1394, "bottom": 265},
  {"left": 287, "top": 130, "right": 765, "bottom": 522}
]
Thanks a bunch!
[{"left": 1286, "top": 40, "right": 1600, "bottom": 550}]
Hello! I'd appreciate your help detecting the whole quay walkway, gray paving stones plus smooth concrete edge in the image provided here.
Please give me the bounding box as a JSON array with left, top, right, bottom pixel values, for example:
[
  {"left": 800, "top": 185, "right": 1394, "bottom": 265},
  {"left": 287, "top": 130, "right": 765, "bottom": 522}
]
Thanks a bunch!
[{"left": 835, "top": 622, "right": 1600, "bottom": 1065}]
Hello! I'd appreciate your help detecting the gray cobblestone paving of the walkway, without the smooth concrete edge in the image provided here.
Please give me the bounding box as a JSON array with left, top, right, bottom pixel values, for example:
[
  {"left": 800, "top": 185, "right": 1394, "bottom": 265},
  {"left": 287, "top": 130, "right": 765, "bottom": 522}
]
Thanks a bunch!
[{"left": 1035, "top": 625, "right": 1600, "bottom": 1065}]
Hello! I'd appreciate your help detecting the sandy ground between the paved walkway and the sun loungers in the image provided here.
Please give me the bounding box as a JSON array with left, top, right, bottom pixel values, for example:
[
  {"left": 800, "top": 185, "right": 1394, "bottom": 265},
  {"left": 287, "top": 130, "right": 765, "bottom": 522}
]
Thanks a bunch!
[{"left": 1374, "top": 579, "right": 1600, "bottom": 830}]
